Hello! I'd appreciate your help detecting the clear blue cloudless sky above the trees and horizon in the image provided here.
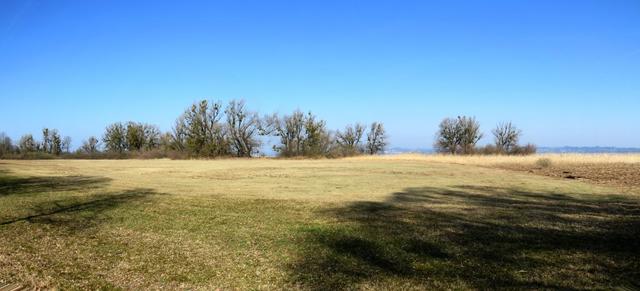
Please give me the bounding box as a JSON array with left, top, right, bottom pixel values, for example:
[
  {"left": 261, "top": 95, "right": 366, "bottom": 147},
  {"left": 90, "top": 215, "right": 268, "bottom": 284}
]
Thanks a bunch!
[{"left": 0, "top": 0, "right": 640, "bottom": 147}]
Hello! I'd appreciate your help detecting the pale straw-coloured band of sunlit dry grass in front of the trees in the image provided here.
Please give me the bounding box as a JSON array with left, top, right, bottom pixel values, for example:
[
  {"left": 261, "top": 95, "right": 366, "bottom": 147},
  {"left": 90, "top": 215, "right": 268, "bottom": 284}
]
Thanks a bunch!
[{"left": 0, "top": 158, "right": 584, "bottom": 202}]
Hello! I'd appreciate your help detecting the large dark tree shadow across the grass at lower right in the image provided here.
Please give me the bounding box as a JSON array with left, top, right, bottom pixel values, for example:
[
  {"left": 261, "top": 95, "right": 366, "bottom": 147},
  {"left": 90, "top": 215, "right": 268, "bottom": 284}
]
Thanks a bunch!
[{"left": 291, "top": 185, "right": 640, "bottom": 290}]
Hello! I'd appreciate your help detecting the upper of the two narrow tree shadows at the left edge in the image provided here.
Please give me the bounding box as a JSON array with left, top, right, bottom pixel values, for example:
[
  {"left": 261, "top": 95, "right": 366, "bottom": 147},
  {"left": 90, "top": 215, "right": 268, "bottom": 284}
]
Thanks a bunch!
[{"left": 0, "top": 172, "right": 111, "bottom": 198}]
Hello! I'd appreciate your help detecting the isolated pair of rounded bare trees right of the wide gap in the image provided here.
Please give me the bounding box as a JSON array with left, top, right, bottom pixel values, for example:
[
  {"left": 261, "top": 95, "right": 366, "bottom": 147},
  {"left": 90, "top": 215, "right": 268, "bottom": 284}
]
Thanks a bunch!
[{"left": 434, "top": 116, "right": 536, "bottom": 155}]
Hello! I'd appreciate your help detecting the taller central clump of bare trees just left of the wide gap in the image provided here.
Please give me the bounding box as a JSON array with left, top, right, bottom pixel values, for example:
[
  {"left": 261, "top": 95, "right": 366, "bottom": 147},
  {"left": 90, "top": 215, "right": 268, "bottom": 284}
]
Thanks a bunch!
[{"left": 167, "top": 100, "right": 386, "bottom": 157}]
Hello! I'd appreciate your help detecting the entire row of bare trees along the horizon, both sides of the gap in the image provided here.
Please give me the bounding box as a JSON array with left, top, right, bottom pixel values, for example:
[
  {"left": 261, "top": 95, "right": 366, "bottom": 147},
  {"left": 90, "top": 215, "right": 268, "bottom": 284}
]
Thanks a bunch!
[{"left": 0, "top": 106, "right": 536, "bottom": 158}]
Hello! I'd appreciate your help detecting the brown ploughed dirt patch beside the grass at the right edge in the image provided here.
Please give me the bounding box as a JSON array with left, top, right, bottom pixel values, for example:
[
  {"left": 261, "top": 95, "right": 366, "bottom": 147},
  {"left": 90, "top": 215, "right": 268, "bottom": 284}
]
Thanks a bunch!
[{"left": 497, "top": 163, "right": 640, "bottom": 189}]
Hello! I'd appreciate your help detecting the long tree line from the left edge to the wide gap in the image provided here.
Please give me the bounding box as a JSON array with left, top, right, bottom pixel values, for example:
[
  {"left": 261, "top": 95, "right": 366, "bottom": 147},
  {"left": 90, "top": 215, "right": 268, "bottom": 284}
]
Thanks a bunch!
[{"left": 0, "top": 100, "right": 387, "bottom": 158}]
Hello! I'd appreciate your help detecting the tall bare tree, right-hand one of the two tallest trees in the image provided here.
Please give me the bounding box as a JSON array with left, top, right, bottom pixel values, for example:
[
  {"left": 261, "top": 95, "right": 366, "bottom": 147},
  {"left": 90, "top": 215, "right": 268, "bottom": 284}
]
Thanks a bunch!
[{"left": 225, "top": 100, "right": 261, "bottom": 157}]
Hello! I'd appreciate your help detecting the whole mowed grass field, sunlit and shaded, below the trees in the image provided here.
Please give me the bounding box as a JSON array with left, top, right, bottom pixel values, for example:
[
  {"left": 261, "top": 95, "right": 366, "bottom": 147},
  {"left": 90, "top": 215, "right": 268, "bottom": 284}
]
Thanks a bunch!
[{"left": 0, "top": 158, "right": 640, "bottom": 290}]
